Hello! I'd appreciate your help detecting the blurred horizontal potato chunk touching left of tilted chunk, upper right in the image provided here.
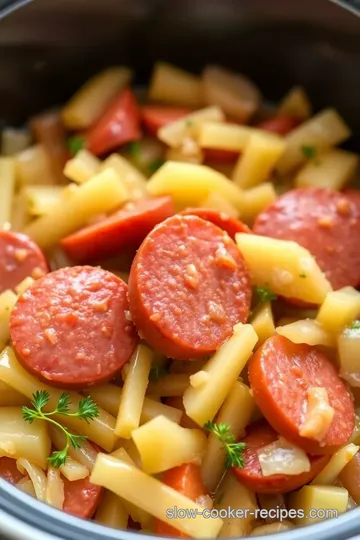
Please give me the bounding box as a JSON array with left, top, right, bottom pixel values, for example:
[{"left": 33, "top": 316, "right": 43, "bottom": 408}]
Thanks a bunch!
[{"left": 197, "top": 121, "right": 255, "bottom": 152}]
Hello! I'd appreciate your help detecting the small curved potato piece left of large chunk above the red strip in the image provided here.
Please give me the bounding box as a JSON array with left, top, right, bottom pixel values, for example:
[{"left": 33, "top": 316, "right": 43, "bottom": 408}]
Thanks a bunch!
[{"left": 100, "top": 154, "right": 148, "bottom": 201}]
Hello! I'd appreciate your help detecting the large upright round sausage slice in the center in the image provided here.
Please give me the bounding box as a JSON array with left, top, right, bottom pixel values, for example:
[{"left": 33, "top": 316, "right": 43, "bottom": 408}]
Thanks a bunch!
[{"left": 129, "top": 215, "right": 251, "bottom": 359}]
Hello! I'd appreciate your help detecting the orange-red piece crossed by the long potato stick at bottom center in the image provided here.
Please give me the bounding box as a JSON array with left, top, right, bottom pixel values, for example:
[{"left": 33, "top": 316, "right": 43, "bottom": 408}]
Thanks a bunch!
[{"left": 154, "top": 463, "right": 208, "bottom": 538}]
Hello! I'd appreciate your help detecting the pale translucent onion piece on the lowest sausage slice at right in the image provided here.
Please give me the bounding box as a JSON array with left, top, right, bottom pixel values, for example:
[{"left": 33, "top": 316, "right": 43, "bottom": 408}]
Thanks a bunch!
[{"left": 258, "top": 437, "right": 311, "bottom": 476}]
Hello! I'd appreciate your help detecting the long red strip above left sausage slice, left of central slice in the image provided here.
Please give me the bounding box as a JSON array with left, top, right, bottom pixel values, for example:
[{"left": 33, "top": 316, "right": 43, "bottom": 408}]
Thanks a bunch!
[{"left": 61, "top": 196, "right": 175, "bottom": 263}]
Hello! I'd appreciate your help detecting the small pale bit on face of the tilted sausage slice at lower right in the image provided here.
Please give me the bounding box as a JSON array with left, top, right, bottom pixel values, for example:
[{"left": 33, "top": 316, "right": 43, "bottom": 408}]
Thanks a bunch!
[{"left": 300, "top": 386, "right": 335, "bottom": 441}]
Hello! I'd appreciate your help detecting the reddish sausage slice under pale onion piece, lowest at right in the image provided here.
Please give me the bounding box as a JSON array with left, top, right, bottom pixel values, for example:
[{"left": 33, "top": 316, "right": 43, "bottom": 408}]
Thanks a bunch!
[{"left": 233, "top": 420, "right": 330, "bottom": 493}]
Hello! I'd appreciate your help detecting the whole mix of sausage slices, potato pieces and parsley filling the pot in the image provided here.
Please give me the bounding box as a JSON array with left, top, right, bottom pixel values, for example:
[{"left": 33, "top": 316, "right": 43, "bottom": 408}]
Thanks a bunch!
[{"left": 0, "top": 62, "right": 360, "bottom": 538}]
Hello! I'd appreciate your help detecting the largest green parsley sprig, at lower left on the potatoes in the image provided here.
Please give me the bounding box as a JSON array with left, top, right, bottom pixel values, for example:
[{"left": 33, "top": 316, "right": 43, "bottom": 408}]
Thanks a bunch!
[{"left": 21, "top": 390, "right": 99, "bottom": 468}]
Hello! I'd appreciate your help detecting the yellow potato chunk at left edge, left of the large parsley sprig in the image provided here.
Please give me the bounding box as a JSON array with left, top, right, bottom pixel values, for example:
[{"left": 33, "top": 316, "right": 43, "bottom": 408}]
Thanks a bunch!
[{"left": 0, "top": 407, "right": 51, "bottom": 469}]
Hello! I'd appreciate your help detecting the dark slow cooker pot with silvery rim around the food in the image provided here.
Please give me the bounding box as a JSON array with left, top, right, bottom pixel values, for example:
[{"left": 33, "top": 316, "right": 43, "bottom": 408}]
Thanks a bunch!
[{"left": 0, "top": 0, "right": 360, "bottom": 540}]
